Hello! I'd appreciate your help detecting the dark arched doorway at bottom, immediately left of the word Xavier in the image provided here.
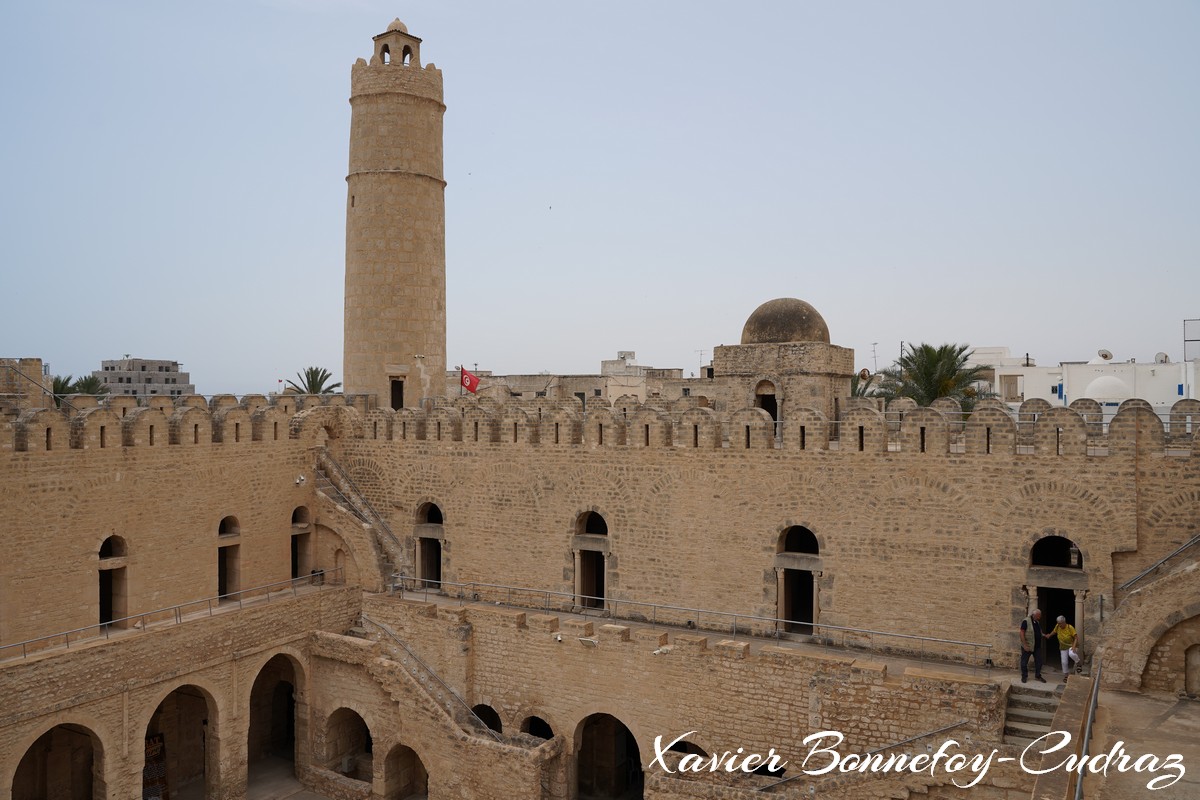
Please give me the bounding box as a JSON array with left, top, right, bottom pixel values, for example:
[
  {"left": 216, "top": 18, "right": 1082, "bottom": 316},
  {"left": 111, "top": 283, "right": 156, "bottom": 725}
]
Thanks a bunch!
[{"left": 575, "top": 714, "right": 644, "bottom": 800}]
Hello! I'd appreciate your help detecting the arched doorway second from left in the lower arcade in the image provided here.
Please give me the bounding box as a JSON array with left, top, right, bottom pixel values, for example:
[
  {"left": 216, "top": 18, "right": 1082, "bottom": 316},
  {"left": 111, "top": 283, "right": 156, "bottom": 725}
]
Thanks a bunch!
[{"left": 142, "top": 686, "right": 221, "bottom": 800}]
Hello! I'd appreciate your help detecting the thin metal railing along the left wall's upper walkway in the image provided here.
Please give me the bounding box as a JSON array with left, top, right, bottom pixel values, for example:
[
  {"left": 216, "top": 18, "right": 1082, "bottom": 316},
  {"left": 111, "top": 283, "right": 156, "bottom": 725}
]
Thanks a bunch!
[{"left": 0, "top": 567, "right": 342, "bottom": 661}]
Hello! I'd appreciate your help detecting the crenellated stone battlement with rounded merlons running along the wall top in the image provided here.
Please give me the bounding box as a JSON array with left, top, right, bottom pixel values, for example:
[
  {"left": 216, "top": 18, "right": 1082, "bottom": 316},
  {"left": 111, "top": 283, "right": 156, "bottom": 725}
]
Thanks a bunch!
[{"left": 2, "top": 395, "right": 1200, "bottom": 457}]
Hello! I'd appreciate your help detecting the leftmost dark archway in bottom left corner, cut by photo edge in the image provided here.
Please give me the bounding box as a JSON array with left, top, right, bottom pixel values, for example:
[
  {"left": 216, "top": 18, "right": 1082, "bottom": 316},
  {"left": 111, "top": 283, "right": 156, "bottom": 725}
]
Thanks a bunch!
[{"left": 12, "top": 724, "right": 108, "bottom": 800}]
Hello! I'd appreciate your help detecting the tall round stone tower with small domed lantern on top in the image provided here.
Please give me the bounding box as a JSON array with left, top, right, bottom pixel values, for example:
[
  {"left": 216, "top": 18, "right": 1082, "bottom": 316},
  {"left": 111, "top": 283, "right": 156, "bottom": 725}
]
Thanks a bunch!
[{"left": 343, "top": 19, "right": 446, "bottom": 408}]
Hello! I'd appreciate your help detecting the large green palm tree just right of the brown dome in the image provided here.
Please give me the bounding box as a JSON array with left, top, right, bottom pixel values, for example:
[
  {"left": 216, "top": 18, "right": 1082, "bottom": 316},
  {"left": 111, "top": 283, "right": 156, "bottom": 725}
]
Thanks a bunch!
[{"left": 878, "top": 344, "right": 988, "bottom": 413}]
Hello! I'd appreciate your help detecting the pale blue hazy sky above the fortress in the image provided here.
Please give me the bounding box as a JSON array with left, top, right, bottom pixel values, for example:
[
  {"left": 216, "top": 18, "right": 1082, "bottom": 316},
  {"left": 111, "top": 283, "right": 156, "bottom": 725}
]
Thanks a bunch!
[{"left": 0, "top": 0, "right": 1200, "bottom": 393}]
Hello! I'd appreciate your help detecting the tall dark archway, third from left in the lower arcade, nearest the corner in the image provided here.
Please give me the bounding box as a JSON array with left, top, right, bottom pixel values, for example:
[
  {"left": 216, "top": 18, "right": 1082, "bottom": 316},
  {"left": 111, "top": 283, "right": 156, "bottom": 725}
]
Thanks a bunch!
[{"left": 246, "top": 654, "right": 299, "bottom": 781}]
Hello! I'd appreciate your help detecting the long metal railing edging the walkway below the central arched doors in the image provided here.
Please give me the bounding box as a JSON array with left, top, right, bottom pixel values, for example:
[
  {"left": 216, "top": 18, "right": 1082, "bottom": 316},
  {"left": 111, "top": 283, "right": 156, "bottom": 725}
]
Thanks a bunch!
[{"left": 391, "top": 573, "right": 992, "bottom": 669}]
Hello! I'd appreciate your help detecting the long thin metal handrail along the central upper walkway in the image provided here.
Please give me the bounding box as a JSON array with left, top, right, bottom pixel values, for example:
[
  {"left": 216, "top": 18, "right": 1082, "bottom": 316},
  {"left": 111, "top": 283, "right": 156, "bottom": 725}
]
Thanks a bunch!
[{"left": 391, "top": 573, "right": 992, "bottom": 661}]
